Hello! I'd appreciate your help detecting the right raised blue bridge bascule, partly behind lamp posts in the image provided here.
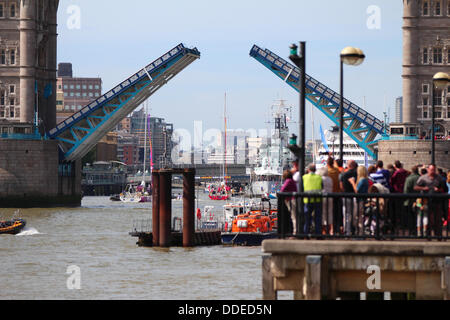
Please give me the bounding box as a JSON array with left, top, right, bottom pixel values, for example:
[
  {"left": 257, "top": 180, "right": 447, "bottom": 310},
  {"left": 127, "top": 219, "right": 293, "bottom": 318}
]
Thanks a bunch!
[{"left": 250, "top": 45, "right": 385, "bottom": 159}]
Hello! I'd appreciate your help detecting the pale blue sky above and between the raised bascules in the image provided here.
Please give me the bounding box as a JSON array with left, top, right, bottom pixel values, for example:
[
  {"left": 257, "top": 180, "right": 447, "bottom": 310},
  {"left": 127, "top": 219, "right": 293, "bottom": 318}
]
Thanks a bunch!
[{"left": 58, "top": 0, "right": 403, "bottom": 138}]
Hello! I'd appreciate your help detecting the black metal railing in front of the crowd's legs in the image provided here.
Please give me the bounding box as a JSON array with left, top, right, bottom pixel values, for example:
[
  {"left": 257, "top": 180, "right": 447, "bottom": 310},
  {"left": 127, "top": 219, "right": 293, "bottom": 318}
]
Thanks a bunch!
[{"left": 277, "top": 193, "right": 450, "bottom": 240}]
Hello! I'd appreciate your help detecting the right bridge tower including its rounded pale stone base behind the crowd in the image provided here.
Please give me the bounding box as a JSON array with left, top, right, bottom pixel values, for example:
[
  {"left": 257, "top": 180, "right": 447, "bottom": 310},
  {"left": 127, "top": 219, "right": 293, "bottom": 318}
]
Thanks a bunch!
[{"left": 378, "top": 0, "right": 450, "bottom": 169}]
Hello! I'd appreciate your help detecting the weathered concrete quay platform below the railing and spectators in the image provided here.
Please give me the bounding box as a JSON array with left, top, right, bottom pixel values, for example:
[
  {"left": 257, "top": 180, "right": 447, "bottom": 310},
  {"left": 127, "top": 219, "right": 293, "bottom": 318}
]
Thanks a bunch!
[{"left": 262, "top": 240, "right": 450, "bottom": 300}]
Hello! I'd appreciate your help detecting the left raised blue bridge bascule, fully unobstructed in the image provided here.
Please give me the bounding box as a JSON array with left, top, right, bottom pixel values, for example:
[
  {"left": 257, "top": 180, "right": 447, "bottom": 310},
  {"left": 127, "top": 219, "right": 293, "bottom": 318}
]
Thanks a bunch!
[{"left": 48, "top": 44, "right": 200, "bottom": 161}]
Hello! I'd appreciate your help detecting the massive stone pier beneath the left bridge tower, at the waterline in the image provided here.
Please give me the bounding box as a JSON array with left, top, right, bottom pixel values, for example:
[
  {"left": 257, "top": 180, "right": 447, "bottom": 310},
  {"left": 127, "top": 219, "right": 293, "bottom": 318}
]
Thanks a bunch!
[{"left": 0, "top": 139, "right": 81, "bottom": 208}]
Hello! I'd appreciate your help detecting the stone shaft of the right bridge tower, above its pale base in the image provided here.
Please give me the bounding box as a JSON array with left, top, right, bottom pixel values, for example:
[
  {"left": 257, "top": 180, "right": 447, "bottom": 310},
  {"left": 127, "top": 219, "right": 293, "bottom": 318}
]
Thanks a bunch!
[{"left": 402, "top": 0, "right": 450, "bottom": 136}]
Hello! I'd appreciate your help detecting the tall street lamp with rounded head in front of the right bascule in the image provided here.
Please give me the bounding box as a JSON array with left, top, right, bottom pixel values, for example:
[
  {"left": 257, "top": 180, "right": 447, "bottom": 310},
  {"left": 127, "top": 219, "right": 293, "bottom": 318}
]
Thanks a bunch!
[{"left": 339, "top": 47, "right": 366, "bottom": 162}]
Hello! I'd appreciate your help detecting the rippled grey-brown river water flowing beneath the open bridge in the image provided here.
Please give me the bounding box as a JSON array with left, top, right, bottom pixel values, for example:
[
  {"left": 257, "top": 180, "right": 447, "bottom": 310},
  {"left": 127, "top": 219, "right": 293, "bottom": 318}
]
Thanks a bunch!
[{"left": 0, "top": 194, "right": 268, "bottom": 300}]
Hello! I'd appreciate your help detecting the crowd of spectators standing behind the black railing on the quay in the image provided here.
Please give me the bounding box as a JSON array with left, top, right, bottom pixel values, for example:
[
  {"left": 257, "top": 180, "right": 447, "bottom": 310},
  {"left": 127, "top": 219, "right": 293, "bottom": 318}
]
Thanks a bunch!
[{"left": 281, "top": 157, "right": 450, "bottom": 236}]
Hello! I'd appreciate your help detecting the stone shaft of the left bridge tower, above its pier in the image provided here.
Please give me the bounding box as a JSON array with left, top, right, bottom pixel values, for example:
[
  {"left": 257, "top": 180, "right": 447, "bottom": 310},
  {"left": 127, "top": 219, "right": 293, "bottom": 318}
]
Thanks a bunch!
[{"left": 0, "top": 0, "right": 59, "bottom": 131}]
